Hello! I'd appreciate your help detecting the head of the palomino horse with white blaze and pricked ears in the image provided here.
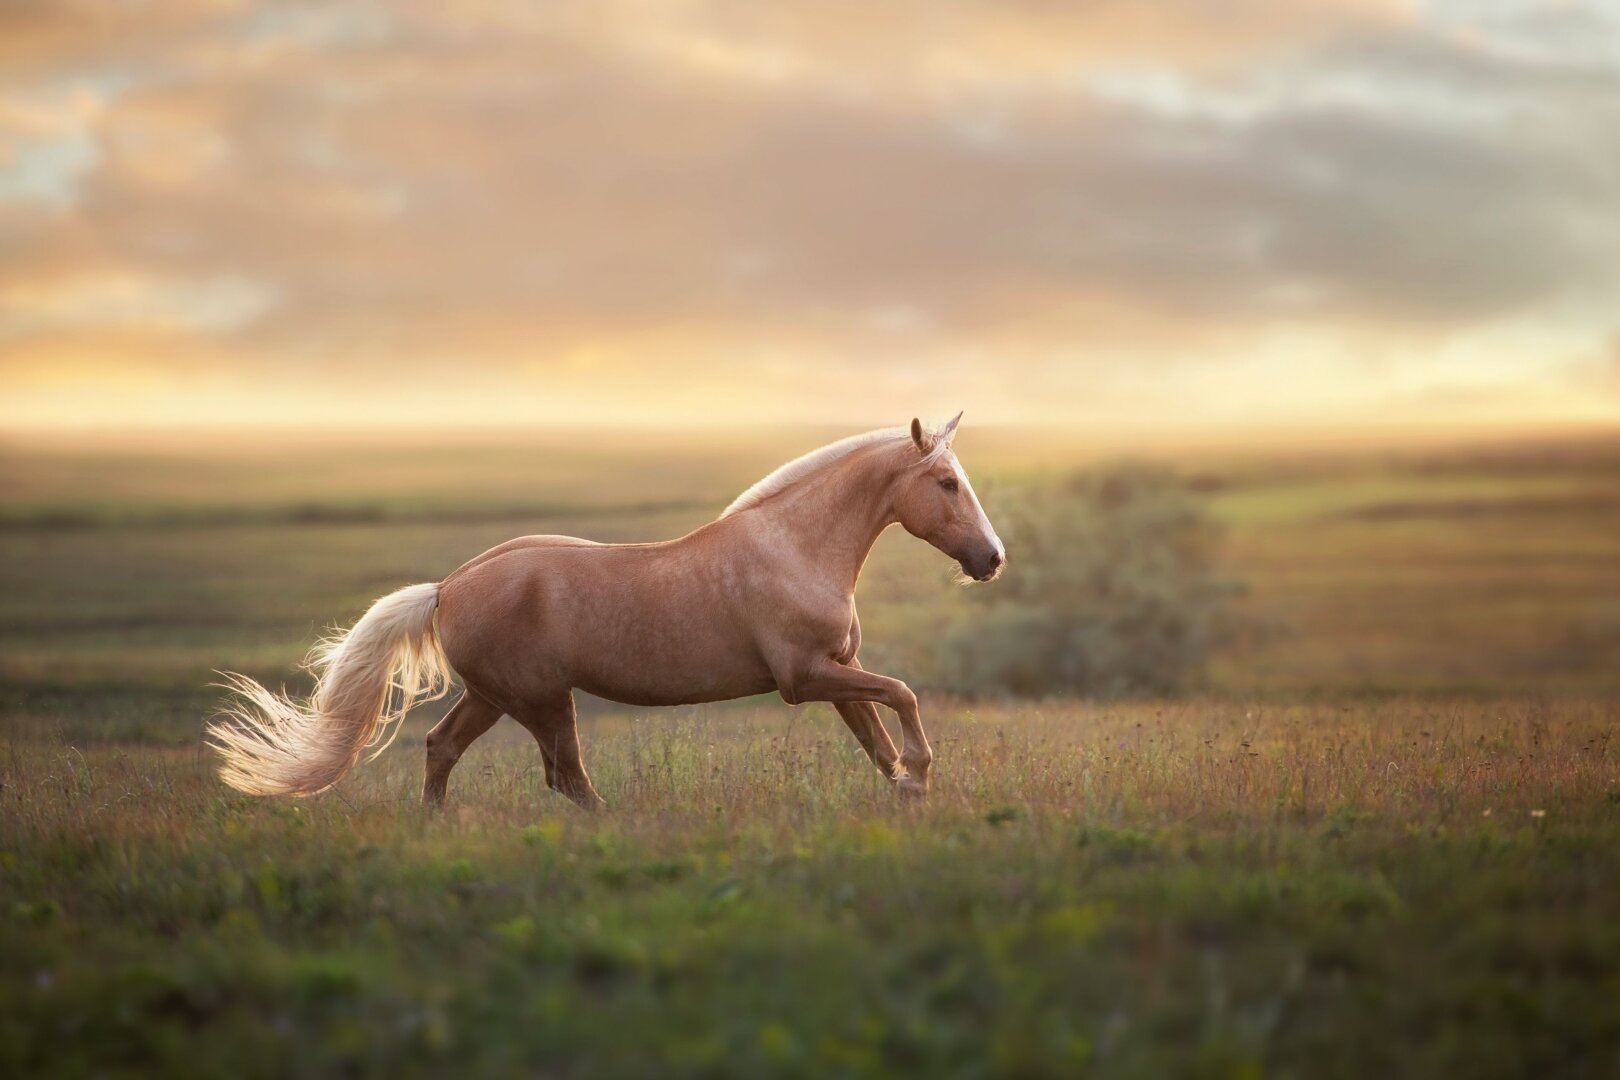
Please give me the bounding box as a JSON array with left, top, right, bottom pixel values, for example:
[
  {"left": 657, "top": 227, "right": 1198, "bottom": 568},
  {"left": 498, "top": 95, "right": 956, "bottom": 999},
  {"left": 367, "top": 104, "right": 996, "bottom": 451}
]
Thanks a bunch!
[{"left": 894, "top": 413, "right": 1008, "bottom": 581}]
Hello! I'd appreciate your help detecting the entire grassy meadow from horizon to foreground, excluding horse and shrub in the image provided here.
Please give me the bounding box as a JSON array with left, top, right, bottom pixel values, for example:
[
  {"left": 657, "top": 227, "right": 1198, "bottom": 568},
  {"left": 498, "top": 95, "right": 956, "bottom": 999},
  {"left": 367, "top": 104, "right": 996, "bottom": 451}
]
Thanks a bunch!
[{"left": 0, "top": 432, "right": 1620, "bottom": 1077}]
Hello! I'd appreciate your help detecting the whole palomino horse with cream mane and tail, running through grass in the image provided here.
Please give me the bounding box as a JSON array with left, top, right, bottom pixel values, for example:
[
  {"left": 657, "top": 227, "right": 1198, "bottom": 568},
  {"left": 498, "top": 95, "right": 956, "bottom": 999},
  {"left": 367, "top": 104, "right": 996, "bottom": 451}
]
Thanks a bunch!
[{"left": 209, "top": 413, "right": 1006, "bottom": 806}]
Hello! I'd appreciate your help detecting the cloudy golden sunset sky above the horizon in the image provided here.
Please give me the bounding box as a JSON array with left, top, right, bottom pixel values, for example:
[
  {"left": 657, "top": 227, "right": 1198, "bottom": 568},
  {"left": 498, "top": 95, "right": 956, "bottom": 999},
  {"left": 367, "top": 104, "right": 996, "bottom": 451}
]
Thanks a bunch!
[{"left": 0, "top": 0, "right": 1620, "bottom": 434}]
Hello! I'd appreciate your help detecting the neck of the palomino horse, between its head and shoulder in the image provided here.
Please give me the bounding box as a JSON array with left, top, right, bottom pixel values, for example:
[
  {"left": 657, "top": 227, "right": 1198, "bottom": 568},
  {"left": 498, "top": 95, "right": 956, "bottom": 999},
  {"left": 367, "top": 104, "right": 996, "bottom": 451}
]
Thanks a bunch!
[{"left": 760, "top": 447, "right": 894, "bottom": 591}]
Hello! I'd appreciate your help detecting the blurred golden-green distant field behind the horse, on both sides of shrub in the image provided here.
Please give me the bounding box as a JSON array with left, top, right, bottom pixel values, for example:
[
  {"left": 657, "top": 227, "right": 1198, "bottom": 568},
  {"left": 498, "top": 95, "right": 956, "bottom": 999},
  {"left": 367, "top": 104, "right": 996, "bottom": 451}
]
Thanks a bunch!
[{"left": 0, "top": 431, "right": 1620, "bottom": 718}]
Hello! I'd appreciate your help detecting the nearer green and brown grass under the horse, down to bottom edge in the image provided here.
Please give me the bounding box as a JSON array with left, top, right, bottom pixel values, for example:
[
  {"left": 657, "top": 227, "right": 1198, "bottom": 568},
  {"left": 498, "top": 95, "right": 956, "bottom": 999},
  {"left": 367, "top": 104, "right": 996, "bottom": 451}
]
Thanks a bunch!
[{"left": 9, "top": 703, "right": 1620, "bottom": 1077}]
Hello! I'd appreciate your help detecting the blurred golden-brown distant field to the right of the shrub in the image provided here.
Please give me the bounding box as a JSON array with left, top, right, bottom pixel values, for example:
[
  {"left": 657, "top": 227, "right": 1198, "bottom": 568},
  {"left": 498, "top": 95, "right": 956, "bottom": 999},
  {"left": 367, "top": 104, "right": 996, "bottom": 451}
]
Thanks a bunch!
[{"left": 1212, "top": 444, "right": 1620, "bottom": 696}]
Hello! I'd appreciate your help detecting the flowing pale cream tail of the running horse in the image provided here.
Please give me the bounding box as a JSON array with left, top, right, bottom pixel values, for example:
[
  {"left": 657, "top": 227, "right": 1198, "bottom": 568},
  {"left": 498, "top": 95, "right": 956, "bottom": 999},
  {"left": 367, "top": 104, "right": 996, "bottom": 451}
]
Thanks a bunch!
[{"left": 207, "top": 585, "right": 450, "bottom": 795}]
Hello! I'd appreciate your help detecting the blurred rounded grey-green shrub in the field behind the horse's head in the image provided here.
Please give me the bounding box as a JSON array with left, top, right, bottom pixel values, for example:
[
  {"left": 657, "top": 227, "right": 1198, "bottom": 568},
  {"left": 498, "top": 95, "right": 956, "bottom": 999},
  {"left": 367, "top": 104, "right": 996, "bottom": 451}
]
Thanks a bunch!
[{"left": 940, "top": 463, "right": 1234, "bottom": 696}]
